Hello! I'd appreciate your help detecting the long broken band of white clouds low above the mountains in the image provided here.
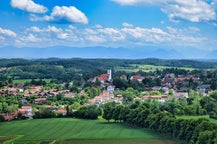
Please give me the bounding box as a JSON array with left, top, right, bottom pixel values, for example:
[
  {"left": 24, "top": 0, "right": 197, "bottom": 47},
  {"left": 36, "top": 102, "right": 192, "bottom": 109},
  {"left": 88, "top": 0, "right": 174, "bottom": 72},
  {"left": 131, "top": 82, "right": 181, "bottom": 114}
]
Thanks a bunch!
[{"left": 22, "top": 23, "right": 207, "bottom": 47}]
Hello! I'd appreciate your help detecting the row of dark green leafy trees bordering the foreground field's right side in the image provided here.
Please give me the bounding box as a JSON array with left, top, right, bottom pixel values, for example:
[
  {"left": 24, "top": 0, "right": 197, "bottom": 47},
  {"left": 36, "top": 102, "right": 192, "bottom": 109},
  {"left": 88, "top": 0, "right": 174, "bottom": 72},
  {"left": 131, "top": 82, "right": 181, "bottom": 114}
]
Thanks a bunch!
[{"left": 103, "top": 103, "right": 217, "bottom": 144}]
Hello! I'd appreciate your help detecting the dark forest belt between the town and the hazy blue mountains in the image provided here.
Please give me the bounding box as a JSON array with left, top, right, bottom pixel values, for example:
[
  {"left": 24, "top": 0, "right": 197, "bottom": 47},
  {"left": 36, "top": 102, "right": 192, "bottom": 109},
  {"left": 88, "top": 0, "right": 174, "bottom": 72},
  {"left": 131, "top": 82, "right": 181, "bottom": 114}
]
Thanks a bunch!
[{"left": 0, "top": 58, "right": 217, "bottom": 81}]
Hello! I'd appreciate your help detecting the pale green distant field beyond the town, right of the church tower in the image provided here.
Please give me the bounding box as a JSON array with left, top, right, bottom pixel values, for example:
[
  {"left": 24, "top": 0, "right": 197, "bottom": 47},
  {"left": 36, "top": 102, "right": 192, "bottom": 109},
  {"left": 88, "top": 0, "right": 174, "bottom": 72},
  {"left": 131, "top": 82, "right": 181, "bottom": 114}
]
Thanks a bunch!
[{"left": 116, "top": 64, "right": 194, "bottom": 72}]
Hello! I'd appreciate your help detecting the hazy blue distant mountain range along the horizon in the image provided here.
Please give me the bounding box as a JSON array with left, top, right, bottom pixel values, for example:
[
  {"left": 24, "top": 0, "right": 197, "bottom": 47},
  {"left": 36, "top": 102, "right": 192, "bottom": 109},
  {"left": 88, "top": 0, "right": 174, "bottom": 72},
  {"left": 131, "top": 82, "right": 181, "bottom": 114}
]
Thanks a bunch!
[{"left": 0, "top": 46, "right": 217, "bottom": 59}]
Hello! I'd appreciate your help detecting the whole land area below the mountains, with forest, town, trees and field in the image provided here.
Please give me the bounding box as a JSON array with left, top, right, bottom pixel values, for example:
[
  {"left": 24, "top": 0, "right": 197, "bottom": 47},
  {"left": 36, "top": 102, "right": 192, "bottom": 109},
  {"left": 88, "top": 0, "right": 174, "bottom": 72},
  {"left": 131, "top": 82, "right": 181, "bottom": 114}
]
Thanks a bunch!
[{"left": 0, "top": 59, "right": 217, "bottom": 143}]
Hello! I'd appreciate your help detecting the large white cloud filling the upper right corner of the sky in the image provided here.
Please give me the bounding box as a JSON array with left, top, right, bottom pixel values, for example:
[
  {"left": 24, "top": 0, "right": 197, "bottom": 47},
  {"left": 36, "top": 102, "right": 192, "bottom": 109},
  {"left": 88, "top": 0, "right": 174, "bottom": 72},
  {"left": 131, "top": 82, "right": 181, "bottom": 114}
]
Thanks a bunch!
[{"left": 112, "top": 0, "right": 216, "bottom": 22}]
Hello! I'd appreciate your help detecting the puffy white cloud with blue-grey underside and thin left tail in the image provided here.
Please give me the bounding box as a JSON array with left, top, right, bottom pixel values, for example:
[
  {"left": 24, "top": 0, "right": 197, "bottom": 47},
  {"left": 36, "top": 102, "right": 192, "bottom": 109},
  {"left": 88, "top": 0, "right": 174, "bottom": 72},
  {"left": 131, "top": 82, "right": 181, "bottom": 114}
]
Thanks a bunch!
[{"left": 30, "top": 6, "right": 88, "bottom": 24}]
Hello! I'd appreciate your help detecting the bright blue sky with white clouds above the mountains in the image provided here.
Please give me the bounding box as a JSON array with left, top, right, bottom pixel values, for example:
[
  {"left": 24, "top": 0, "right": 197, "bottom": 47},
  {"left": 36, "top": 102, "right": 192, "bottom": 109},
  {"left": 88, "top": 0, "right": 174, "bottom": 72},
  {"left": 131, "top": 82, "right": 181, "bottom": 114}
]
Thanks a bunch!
[{"left": 0, "top": 0, "right": 217, "bottom": 58}]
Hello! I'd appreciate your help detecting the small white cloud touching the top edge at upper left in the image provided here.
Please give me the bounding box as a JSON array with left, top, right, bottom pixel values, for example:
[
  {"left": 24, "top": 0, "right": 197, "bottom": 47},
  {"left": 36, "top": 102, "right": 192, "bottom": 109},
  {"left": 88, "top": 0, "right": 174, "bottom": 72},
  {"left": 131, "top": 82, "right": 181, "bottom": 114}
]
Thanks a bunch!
[{"left": 11, "top": 0, "right": 48, "bottom": 13}]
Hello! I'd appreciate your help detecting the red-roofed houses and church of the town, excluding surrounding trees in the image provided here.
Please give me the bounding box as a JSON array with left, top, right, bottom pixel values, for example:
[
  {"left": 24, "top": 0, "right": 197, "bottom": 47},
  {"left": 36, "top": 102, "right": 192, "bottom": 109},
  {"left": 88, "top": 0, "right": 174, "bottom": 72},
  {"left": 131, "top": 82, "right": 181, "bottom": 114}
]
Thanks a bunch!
[{"left": 0, "top": 68, "right": 210, "bottom": 120}]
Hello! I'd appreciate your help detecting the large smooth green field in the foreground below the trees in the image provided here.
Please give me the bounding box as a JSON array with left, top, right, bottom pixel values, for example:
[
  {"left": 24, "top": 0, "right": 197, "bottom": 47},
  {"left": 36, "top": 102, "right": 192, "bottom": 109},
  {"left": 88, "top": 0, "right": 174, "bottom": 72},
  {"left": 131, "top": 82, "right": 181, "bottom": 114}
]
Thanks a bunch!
[{"left": 0, "top": 118, "right": 177, "bottom": 144}]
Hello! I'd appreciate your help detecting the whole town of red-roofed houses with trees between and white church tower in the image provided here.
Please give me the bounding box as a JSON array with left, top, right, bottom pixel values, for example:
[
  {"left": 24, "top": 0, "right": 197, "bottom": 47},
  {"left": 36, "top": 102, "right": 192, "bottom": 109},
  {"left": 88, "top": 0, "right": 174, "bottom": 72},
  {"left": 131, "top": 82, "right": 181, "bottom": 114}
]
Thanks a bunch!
[{"left": 0, "top": 64, "right": 215, "bottom": 121}]
